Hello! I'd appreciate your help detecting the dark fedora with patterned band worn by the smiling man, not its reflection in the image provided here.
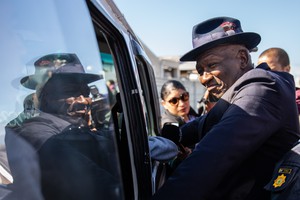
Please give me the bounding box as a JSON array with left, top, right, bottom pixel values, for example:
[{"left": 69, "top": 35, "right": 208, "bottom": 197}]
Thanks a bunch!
[{"left": 180, "top": 17, "right": 261, "bottom": 61}]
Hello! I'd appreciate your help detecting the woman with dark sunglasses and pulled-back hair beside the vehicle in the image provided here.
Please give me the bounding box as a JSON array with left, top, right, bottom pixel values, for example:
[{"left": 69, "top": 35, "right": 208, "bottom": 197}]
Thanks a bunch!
[{"left": 160, "top": 80, "right": 197, "bottom": 126}]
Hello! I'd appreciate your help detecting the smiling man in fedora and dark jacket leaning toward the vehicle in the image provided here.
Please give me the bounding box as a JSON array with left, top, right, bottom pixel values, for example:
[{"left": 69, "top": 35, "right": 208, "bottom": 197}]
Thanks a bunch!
[{"left": 154, "top": 17, "right": 300, "bottom": 200}]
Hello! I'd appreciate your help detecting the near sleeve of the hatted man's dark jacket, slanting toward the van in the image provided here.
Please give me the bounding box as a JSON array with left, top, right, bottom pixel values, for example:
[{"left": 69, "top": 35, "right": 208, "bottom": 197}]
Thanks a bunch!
[{"left": 154, "top": 70, "right": 288, "bottom": 199}]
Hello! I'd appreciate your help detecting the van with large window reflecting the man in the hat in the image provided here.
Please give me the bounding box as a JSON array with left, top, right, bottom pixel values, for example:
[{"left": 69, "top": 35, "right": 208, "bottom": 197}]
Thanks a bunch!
[{"left": 0, "top": 0, "right": 164, "bottom": 200}]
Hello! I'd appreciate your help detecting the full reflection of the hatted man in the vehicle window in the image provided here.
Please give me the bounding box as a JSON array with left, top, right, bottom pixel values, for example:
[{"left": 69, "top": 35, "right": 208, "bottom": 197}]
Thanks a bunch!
[{"left": 6, "top": 54, "right": 117, "bottom": 199}]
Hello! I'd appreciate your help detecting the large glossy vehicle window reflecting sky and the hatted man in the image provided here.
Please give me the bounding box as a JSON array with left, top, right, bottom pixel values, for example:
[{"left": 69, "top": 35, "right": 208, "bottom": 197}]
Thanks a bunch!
[{"left": 0, "top": 0, "right": 123, "bottom": 199}]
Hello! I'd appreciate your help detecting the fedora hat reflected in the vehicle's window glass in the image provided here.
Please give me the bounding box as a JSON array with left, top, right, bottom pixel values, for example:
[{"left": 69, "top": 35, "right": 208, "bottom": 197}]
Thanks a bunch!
[{"left": 20, "top": 53, "right": 102, "bottom": 90}]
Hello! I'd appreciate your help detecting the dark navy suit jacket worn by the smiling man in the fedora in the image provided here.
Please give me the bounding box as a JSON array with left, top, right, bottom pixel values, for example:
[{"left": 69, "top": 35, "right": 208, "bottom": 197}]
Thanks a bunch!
[{"left": 154, "top": 65, "right": 299, "bottom": 200}]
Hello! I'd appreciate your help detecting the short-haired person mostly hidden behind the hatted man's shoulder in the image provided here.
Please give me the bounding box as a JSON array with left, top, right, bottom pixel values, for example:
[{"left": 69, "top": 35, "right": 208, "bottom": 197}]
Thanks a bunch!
[{"left": 257, "top": 47, "right": 300, "bottom": 118}]
